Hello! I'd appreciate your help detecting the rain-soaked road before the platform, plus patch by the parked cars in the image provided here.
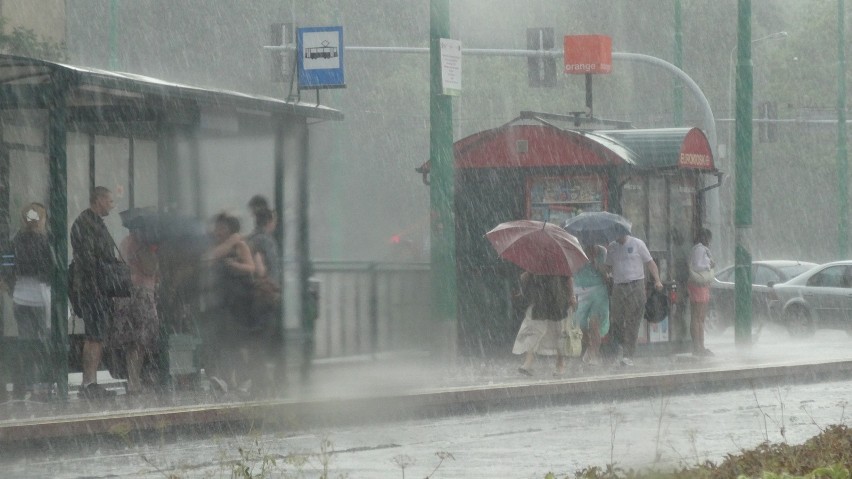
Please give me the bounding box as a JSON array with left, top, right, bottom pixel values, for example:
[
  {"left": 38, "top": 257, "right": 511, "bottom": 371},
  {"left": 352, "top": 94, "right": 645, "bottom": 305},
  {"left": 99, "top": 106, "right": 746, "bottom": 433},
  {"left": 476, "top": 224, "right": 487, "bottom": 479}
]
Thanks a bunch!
[{"left": 6, "top": 324, "right": 852, "bottom": 479}]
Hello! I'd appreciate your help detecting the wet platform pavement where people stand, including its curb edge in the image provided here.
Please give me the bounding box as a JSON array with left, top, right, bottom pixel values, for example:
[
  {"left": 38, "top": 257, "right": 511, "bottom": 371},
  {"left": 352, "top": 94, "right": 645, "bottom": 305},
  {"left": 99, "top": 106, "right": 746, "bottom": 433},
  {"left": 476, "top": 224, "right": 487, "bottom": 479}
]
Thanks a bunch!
[{"left": 0, "top": 331, "right": 852, "bottom": 443}]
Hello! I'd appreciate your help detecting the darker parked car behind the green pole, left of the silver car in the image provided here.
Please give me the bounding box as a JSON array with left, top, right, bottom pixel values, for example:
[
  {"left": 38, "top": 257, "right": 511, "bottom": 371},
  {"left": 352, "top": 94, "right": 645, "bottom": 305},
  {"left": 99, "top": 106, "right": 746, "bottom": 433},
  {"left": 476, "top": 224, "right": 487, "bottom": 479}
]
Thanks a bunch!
[{"left": 704, "top": 260, "right": 817, "bottom": 333}]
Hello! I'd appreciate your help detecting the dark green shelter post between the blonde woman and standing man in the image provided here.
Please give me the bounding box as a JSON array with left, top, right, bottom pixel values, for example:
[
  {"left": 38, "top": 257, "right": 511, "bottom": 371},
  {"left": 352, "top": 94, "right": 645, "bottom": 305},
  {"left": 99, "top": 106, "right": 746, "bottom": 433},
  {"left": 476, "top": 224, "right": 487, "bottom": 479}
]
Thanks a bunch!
[{"left": 47, "top": 74, "right": 70, "bottom": 400}]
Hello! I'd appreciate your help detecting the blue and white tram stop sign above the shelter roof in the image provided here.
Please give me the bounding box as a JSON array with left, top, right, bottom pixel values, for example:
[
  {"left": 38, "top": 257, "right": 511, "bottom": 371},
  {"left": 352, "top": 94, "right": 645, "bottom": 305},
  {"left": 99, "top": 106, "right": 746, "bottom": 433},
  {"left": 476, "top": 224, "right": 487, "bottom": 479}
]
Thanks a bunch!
[{"left": 296, "top": 27, "right": 346, "bottom": 90}]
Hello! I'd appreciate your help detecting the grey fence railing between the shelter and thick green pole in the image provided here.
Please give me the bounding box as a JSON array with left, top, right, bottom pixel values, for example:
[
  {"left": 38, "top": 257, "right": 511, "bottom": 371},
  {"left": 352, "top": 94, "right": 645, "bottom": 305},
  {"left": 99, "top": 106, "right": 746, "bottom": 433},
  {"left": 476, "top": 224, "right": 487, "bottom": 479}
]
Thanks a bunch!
[{"left": 313, "top": 261, "right": 430, "bottom": 359}]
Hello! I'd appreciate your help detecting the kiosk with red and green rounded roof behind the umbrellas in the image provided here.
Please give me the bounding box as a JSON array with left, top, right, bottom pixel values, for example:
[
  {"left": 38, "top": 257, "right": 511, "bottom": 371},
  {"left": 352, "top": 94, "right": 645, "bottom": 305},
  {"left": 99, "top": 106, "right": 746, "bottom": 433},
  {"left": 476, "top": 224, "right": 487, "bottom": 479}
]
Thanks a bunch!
[{"left": 436, "top": 112, "right": 721, "bottom": 354}]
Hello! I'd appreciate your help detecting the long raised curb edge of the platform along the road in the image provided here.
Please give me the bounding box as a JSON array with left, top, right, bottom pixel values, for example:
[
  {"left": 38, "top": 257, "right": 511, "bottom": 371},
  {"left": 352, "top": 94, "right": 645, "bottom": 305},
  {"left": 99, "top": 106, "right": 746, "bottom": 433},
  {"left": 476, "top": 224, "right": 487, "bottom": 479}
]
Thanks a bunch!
[{"left": 0, "top": 360, "right": 852, "bottom": 446}]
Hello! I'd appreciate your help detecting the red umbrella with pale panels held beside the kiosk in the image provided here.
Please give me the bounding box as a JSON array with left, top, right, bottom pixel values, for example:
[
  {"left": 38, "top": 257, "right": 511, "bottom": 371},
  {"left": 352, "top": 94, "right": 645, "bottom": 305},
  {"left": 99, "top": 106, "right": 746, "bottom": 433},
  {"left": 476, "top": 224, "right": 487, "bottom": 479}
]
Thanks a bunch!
[{"left": 485, "top": 220, "right": 589, "bottom": 276}]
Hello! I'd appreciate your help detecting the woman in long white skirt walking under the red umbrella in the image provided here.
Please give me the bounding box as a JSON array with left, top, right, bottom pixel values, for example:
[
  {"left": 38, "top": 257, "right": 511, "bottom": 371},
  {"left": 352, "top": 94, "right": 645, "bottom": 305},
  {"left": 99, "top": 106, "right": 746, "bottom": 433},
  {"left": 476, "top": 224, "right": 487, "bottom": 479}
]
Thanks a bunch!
[{"left": 512, "top": 271, "right": 577, "bottom": 376}]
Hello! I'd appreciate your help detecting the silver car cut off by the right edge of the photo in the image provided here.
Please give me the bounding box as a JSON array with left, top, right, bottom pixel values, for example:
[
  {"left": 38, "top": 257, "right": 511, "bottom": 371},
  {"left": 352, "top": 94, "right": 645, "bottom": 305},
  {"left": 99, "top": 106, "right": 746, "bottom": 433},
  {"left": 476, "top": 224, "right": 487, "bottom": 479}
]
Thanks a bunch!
[{"left": 772, "top": 261, "right": 852, "bottom": 336}]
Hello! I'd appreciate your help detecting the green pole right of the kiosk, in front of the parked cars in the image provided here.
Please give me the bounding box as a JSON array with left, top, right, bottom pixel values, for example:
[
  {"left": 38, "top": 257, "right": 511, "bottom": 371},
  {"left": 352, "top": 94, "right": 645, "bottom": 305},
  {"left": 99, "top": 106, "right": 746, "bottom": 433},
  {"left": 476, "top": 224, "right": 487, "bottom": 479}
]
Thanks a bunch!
[{"left": 734, "top": 0, "right": 752, "bottom": 346}]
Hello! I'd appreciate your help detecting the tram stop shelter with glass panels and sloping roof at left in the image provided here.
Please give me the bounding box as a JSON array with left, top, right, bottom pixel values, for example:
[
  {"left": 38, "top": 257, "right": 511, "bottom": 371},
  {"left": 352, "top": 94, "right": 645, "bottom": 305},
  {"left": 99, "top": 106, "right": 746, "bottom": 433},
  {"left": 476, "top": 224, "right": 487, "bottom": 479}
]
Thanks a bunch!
[{"left": 0, "top": 51, "right": 343, "bottom": 397}]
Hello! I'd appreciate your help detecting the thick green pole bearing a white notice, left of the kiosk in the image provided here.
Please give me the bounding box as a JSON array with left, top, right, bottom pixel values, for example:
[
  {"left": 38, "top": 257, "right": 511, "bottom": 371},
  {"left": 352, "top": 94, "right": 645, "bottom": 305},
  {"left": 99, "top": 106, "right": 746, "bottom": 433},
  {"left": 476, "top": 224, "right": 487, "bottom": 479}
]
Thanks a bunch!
[{"left": 429, "top": 0, "right": 457, "bottom": 357}]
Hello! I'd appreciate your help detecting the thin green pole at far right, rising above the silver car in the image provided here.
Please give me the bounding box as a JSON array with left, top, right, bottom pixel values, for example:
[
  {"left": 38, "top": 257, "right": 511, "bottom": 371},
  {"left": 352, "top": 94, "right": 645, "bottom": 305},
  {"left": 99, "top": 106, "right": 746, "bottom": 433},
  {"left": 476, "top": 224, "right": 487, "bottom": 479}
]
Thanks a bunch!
[{"left": 837, "top": 0, "right": 849, "bottom": 259}]
